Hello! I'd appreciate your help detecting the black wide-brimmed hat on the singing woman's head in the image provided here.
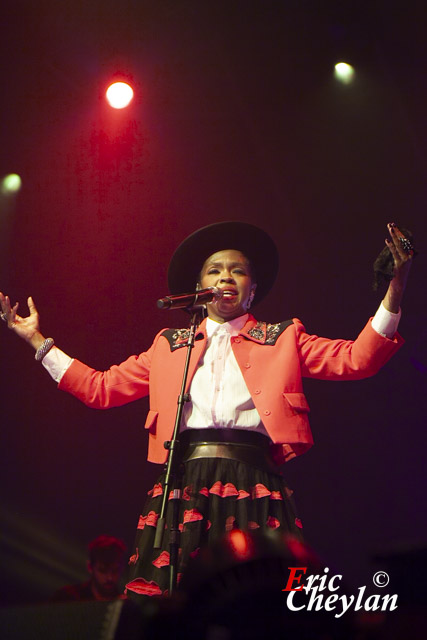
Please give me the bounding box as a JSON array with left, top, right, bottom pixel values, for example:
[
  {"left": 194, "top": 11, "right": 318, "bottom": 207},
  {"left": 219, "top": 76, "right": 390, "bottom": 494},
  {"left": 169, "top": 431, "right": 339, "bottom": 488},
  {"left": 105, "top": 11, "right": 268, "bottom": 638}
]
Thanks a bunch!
[{"left": 168, "top": 221, "right": 279, "bottom": 303}]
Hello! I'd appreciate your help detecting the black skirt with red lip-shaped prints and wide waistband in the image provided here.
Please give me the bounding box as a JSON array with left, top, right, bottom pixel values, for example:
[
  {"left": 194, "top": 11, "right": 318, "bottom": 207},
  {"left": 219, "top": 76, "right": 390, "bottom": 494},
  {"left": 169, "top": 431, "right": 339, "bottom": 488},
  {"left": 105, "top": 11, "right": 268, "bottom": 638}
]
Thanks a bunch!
[{"left": 126, "top": 429, "right": 302, "bottom": 599}]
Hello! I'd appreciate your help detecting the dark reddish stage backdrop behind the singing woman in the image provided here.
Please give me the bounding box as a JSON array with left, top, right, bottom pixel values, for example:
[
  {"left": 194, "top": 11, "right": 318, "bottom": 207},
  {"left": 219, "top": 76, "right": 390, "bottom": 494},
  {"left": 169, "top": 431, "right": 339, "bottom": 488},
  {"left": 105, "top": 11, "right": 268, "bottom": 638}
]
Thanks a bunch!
[{"left": 0, "top": 0, "right": 427, "bottom": 603}]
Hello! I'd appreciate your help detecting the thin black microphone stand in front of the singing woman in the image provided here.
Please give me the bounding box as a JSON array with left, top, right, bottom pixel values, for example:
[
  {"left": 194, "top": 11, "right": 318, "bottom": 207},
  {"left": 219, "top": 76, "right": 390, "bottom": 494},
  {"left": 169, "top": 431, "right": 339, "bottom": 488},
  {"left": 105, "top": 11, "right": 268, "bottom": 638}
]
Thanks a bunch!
[{"left": 153, "top": 307, "right": 201, "bottom": 595}]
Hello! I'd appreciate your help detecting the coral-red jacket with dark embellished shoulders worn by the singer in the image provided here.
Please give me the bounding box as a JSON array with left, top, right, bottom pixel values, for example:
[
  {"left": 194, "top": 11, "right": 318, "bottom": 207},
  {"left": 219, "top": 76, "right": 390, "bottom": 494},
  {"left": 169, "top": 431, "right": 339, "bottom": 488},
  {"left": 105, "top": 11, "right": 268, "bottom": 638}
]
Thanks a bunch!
[{"left": 59, "top": 315, "right": 403, "bottom": 463}]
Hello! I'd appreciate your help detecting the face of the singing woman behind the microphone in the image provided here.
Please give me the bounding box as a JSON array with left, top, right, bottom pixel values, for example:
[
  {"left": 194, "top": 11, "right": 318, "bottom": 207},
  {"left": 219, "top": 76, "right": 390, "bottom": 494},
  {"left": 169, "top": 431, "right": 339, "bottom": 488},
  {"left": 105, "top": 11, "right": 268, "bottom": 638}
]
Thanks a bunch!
[{"left": 200, "top": 249, "right": 256, "bottom": 323}]
